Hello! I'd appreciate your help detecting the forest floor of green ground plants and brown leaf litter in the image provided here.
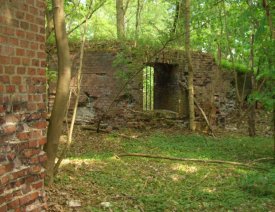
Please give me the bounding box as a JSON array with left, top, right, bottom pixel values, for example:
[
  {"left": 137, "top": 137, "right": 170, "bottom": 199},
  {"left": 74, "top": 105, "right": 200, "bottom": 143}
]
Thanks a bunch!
[{"left": 47, "top": 128, "right": 275, "bottom": 212}]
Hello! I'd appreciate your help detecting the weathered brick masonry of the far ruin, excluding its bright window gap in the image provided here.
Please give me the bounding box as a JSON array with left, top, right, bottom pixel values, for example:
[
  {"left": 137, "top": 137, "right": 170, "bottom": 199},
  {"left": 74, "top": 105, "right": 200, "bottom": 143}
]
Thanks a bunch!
[{"left": 50, "top": 44, "right": 235, "bottom": 125}]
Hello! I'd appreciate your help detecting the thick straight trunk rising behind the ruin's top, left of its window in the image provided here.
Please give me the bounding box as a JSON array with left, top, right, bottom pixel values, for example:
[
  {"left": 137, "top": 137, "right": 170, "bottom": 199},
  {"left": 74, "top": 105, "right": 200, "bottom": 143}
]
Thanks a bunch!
[{"left": 116, "top": 0, "right": 125, "bottom": 40}]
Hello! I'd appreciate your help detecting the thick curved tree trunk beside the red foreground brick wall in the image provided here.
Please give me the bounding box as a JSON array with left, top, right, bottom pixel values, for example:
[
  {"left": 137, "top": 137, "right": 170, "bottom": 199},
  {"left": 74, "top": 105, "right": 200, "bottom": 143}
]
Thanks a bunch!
[{"left": 44, "top": 0, "right": 71, "bottom": 184}]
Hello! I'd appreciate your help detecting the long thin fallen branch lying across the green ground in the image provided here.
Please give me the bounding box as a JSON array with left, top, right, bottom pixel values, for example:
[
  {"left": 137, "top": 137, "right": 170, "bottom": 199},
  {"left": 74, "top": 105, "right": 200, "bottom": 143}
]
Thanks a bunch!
[{"left": 117, "top": 153, "right": 265, "bottom": 170}]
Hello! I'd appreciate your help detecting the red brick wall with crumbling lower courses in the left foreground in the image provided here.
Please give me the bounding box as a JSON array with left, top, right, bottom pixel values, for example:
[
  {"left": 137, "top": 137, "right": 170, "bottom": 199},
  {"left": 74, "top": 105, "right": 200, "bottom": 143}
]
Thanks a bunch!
[{"left": 0, "top": 0, "right": 47, "bottom": 211}]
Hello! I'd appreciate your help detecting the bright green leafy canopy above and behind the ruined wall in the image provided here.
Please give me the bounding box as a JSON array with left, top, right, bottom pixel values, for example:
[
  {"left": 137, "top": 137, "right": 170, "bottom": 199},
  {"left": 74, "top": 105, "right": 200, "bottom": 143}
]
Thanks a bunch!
[{"left": 47, "top": 0, "right": 275, "bottom": 111}]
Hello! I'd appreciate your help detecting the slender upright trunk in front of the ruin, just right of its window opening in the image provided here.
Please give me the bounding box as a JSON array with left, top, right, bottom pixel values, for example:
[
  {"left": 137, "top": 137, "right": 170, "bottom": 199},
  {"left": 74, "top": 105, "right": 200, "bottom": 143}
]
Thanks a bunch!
[{"left": 185, "top": 0, "right": 196, "bottom": 131}]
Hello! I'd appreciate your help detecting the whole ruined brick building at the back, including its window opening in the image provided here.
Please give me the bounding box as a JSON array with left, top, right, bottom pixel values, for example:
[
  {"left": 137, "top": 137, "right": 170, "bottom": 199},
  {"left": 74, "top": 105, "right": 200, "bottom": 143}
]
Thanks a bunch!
[{"left": 49, "top": 43, "right": 234, "bottom": 125}]
